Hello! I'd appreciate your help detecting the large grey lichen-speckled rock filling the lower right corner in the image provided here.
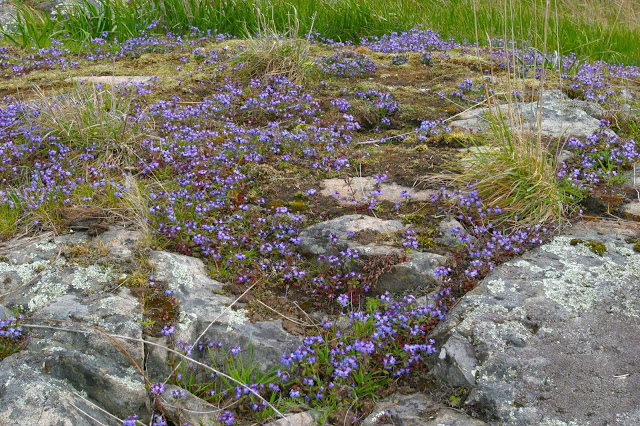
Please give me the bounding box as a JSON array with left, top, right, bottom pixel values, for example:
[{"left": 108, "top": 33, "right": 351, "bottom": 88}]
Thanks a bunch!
[{"left": 430, "top": 224, "right": 640, "bottom": 425}]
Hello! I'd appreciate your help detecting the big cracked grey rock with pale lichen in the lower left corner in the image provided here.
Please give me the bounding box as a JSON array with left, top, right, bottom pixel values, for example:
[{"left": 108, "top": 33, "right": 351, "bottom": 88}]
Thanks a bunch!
[{"left": 0, "top": 231, "right": 147, "bottom": 424}]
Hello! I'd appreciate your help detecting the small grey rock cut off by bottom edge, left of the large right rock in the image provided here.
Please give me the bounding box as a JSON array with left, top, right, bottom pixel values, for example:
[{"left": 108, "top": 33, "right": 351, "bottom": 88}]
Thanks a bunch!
[{"left": 363, "top": 393, "right": 486, "bottom": 426}]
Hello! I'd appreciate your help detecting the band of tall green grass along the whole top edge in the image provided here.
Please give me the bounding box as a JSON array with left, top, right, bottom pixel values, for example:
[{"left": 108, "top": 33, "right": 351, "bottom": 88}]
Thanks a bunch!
[{"left": 0, "top": 0, "right": 640, "bottom": 64}]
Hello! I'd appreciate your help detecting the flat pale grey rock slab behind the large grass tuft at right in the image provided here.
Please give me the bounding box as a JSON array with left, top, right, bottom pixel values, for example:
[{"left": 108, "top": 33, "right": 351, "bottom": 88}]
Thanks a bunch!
[{"left": 451, "top": 90, "right": 606, "bottom": 138}]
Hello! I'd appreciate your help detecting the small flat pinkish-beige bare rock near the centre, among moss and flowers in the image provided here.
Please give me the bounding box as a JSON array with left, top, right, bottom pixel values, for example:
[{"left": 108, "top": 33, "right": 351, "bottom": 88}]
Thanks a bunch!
[{"left": 320, "top": 176, "right": 437, "bottom": 206}]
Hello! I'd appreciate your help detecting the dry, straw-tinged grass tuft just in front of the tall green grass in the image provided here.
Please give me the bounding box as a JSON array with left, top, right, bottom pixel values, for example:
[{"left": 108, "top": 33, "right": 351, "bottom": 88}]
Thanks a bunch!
[{"left": 231, "top": 11, "right": 310, "bottom": 83}]
